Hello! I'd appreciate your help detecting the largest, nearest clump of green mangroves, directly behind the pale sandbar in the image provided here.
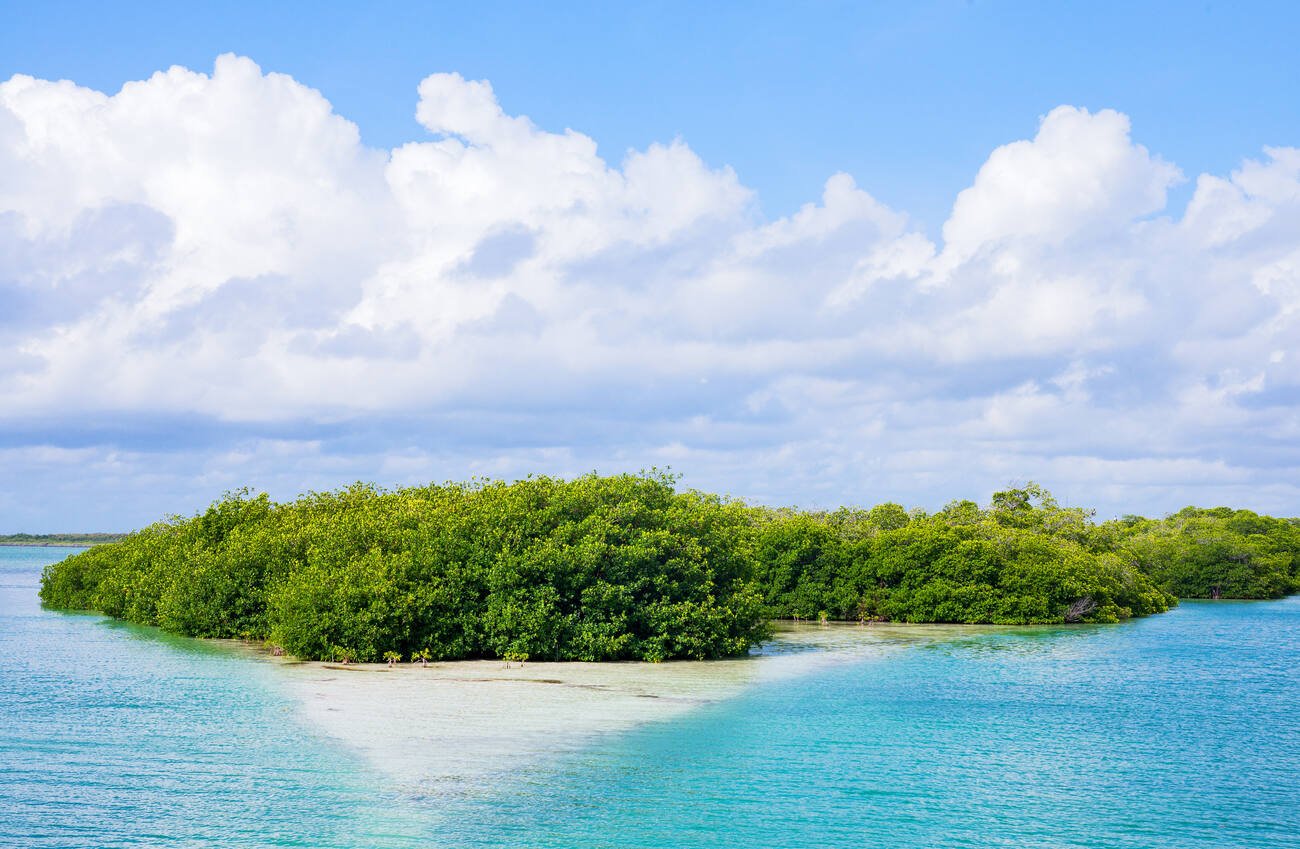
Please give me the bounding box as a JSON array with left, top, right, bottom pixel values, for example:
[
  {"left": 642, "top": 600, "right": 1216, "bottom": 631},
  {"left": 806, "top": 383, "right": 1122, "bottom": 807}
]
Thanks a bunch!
[{"left": 42, "top": 476, "right": 766, "bottom": 660}]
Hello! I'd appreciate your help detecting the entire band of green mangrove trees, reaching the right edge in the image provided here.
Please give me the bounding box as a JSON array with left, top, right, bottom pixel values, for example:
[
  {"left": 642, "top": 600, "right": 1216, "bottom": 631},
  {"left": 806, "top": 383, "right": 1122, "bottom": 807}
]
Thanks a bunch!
[{"left": 40, "top": 472, "right": 1300, "bottom": 662}]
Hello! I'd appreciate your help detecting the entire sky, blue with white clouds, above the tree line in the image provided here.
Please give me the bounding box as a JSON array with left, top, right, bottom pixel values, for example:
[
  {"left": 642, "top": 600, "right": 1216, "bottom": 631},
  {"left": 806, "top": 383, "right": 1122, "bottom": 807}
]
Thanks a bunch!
[{"left": 0, "top": 1, "right": 1300, "bottom": 533}]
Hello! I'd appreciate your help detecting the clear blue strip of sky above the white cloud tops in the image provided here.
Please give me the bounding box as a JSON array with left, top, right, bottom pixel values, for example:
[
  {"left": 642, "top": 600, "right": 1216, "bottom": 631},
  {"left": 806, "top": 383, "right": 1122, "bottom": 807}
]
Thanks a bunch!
[{"left": 10, "top": 0, "right": 1300, "bottom": 230}]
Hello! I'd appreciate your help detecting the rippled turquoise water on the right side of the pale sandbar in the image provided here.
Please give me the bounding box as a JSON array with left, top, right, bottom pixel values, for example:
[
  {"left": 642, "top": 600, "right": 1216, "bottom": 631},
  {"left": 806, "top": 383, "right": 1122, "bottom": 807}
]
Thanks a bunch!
[{"left": 439, "top": 598, "right": 1300, "bottom": 849}]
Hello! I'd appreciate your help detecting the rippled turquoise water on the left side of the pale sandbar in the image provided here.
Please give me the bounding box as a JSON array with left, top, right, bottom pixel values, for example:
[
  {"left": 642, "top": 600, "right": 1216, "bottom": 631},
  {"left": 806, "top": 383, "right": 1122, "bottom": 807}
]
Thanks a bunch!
[{"left": 0, "top": 546, "right": 429, "bottom": 849}]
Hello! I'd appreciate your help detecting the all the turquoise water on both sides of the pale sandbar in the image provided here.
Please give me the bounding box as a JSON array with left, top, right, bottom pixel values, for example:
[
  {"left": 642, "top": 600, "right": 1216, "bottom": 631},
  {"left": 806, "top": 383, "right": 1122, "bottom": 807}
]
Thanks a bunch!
[{"left": 0, "top": 549, "right": 1300, "bottom": 849}]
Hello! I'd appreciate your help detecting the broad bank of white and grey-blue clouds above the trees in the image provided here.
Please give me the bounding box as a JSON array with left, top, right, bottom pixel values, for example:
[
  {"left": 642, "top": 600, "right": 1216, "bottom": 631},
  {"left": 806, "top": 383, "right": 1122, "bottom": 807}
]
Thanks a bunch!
[{"left": 0, "top": 56, "right": 1300, "bottom": 527}]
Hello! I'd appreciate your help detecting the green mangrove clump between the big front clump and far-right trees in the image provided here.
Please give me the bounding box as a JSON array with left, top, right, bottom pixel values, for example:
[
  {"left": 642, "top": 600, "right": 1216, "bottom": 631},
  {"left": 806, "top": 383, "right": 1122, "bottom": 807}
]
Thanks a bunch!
[{"left": 757, "top": 485, "right": 1174, "bottom": 624}]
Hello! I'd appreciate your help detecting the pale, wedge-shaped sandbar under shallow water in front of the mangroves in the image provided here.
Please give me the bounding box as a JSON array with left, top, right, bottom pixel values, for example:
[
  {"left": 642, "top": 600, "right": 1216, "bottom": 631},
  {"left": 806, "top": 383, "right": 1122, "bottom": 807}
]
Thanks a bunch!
[{"left": 271, "top": 625, "right": 1003, "bottom": 796}]
